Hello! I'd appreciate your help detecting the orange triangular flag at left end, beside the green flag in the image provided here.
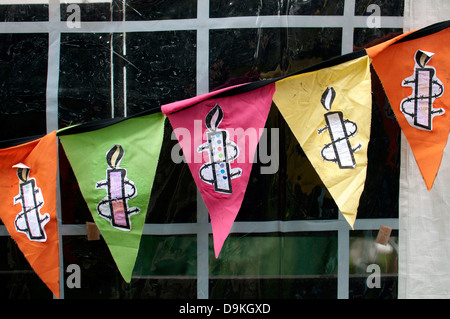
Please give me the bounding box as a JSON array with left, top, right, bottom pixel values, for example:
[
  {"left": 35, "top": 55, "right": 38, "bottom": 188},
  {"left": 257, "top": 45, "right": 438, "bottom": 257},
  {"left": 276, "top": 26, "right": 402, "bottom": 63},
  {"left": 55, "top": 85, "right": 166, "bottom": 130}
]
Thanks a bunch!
[{"left": 0, "top": 132, "right": 60, "bottom": 298}]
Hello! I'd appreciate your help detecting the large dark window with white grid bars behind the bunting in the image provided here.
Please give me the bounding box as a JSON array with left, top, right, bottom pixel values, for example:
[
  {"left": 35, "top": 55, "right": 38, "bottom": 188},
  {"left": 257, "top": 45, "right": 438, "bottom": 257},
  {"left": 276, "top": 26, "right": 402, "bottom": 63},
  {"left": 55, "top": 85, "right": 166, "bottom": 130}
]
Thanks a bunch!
[{"left": 0, "top": 0, "right": 403, "bottom": 299}]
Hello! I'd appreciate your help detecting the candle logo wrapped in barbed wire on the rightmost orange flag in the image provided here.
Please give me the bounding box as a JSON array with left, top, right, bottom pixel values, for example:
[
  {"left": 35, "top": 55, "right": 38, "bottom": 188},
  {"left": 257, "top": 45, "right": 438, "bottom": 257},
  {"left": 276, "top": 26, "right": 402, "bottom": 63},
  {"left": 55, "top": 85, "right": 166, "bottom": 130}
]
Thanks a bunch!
[{"left": 400, "top": 50, "right": 445, "bottom": 131}]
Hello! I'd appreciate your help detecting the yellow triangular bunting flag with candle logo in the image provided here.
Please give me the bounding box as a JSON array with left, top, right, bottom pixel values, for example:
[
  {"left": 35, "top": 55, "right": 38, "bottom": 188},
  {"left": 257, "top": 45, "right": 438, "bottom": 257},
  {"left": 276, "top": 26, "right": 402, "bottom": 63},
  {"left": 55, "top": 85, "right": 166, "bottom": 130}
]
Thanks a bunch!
[{"left": 273, "top": 51, "right": 372, "bottom": 227}]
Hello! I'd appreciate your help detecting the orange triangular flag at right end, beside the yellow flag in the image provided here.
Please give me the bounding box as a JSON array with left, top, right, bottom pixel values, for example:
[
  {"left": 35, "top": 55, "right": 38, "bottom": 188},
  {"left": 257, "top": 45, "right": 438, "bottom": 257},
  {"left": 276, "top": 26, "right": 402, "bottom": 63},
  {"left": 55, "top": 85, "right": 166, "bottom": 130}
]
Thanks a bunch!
[{"left": 367, "top": 21, "right": 450, "bottom": 190}]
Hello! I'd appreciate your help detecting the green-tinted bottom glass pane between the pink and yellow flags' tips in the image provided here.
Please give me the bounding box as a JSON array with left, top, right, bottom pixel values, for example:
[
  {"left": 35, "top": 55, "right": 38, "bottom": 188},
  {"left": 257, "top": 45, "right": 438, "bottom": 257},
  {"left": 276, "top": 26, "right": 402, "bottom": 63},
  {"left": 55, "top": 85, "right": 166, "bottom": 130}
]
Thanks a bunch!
[{"left": 209, "top": 232, "right": 337, "bottom": 299}]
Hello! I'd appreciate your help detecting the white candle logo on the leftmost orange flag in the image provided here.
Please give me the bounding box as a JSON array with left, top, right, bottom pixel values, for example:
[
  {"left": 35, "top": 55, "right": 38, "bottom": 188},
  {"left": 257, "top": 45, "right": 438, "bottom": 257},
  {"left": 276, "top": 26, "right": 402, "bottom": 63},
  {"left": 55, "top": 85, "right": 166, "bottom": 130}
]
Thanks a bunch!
[{"left": 13, "top": 163, "right": 50, "bottom": 242}]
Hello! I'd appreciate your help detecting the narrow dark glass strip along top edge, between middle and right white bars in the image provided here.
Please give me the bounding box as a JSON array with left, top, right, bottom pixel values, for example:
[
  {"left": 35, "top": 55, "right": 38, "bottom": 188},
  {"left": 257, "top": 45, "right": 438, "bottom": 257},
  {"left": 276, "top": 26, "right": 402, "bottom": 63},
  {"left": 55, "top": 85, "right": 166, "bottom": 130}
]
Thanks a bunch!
[{"left": 210, "top": 0, "right": 344, "bottom": 18}]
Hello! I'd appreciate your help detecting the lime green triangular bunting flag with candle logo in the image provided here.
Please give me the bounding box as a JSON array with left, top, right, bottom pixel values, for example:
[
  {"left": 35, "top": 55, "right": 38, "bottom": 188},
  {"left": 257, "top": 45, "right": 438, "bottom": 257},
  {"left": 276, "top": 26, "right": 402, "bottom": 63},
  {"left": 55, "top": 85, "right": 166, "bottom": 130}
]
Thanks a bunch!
[{"left": 58, "top": 112, "right": 165, "bottom": 282}]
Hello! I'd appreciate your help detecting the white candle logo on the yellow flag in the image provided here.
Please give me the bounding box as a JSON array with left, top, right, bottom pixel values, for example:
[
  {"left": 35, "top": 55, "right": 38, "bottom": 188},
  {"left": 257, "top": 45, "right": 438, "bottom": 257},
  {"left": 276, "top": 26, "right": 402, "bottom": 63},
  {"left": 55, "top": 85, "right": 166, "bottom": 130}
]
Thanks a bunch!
[{"left": 318, "top": 87, "right": 362, "bottom": 169}]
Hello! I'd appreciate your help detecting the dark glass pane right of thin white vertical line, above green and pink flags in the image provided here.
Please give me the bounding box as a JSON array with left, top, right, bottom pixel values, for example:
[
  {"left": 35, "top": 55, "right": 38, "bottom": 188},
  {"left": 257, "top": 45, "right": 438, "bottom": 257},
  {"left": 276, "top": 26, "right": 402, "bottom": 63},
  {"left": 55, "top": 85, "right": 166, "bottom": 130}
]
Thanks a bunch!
[{"left": 126, "top": 31, "right": 197, "bottom": 115}]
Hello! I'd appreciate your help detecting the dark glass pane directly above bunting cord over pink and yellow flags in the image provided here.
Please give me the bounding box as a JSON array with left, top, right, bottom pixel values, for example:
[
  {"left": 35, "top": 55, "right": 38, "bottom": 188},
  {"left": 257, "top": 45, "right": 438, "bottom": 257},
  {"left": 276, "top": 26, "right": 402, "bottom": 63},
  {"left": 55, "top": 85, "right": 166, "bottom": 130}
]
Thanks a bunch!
[{"left": 209, "top": 28, "right": 342, "bottom": 90}]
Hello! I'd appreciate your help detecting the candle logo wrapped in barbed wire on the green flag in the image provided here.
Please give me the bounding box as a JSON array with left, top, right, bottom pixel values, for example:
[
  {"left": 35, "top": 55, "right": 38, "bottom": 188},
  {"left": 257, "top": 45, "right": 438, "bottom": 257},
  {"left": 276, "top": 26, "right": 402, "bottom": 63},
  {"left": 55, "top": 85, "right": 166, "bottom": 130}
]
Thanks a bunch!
[{"left": 95, "top": 144, "right": 140, "bottom": 231}]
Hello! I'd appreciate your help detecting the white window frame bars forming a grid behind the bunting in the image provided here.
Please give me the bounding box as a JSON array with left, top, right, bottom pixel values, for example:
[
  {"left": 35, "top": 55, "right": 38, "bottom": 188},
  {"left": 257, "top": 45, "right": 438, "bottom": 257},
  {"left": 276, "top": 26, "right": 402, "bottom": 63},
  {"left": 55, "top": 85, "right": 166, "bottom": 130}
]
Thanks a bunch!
[{"left": 0, "top": 0, "right": 403, "bottom": 299}]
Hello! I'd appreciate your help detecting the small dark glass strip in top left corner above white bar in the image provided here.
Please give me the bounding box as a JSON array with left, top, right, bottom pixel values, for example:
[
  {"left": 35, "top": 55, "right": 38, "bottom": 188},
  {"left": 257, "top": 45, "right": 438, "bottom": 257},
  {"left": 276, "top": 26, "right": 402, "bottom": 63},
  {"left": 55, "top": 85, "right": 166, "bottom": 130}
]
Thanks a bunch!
[{"left": 0, "top": 4, "right": 48, "bottom": 22}]
